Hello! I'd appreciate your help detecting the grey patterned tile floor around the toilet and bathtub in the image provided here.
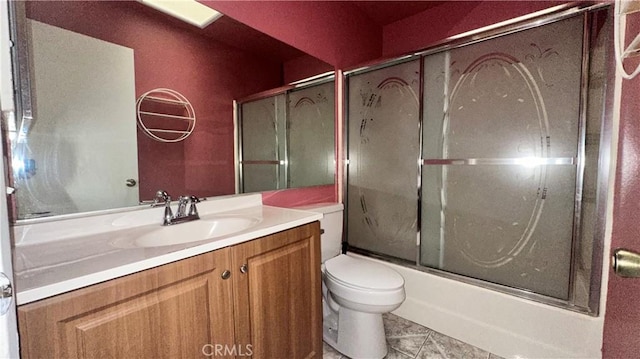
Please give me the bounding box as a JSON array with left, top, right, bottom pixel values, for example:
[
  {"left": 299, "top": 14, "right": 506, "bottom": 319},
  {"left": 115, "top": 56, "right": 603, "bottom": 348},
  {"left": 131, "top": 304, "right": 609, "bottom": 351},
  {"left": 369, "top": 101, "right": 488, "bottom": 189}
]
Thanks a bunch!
[{"left": 322, "top": 314, "right": 501, "bottom": 359}]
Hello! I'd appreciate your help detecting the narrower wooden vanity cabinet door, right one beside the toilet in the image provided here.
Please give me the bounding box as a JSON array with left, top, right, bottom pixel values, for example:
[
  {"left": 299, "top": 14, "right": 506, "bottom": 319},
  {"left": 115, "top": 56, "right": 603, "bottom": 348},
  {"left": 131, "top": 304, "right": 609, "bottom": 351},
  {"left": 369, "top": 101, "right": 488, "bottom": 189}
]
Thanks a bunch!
[{"left": 232, "top": 222, "right": 322, "bottom": 359}]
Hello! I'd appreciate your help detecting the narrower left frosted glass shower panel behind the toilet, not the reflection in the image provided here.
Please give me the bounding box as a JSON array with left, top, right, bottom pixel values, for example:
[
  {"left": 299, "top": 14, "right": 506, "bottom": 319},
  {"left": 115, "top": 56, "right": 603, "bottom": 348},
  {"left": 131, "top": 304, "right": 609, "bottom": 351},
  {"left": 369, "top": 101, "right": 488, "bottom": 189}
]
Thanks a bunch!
[{"left": 347, "top": 61, "right": 420, "bottom": 260}]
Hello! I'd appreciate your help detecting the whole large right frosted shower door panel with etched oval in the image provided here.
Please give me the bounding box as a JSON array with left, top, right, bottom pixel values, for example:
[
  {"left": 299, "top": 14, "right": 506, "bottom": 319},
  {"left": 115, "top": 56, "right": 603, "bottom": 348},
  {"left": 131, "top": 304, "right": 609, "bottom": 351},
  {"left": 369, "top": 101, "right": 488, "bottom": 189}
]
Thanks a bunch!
[{"left": 421, "top": 17, "right": 583, "bottom": 299}]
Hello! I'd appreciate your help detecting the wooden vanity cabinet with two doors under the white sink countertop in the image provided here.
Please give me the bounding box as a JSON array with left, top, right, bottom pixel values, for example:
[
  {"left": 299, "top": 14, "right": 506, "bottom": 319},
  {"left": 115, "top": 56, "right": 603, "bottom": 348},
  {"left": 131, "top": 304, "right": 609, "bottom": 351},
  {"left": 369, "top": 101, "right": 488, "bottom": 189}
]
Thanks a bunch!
[{"left": 18, "top": 222, "right": 322, "bottom": 359}]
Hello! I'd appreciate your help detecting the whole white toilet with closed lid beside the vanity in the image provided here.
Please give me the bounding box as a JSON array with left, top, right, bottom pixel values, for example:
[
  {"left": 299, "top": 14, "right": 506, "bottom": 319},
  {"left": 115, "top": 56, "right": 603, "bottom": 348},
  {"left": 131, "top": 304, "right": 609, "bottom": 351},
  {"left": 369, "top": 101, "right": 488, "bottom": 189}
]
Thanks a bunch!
[{"left": 300, "top": 203, "right": 405, "bottom": 359}]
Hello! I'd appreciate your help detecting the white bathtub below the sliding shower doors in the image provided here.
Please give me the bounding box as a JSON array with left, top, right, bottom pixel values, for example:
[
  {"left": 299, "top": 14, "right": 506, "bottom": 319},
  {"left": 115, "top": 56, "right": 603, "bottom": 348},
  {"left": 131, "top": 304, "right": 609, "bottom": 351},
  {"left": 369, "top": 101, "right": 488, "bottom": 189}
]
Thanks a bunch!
[{"left": 349, "top": 251, "right": 608, "bottom": 358}]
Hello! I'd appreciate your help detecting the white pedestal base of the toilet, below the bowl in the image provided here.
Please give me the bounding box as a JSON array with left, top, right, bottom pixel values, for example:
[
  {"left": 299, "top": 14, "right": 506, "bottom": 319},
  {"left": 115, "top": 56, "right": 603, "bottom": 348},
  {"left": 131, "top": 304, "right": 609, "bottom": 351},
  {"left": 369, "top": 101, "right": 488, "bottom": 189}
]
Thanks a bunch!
[{"left": 322, "top": 307, "right": 387, "bottom": 359}]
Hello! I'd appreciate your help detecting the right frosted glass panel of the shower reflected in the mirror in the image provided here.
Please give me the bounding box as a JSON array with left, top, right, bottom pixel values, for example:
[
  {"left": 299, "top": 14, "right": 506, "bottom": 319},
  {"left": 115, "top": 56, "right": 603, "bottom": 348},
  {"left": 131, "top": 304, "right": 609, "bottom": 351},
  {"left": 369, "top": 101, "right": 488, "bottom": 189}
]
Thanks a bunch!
[{"left": 287, "top": 81, "right": 336, "bottom": 187}]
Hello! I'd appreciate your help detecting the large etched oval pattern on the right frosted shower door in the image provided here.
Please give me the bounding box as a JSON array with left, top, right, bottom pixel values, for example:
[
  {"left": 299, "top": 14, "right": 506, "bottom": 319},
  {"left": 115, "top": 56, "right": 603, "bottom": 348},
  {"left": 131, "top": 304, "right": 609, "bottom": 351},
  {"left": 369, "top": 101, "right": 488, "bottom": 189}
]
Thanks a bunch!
[{"left": 442, "top": 53, "right": 551, "bottom": 267}]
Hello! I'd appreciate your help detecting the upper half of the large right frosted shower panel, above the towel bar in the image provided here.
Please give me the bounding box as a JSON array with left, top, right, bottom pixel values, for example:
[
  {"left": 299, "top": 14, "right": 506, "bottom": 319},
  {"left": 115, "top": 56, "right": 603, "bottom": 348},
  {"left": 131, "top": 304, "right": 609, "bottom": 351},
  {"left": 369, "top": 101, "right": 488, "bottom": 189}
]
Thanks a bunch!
[{"left": 424, "top": 17, "right": 583, "bottom": 158}]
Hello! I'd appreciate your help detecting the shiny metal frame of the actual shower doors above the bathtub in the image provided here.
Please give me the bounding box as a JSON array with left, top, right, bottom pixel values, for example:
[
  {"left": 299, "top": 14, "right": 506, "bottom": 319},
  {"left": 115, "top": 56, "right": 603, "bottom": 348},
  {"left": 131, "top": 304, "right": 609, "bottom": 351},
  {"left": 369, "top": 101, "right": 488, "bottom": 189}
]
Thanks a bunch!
[{"left": 342, "top": 3, "right": 615, "bottom": 316}]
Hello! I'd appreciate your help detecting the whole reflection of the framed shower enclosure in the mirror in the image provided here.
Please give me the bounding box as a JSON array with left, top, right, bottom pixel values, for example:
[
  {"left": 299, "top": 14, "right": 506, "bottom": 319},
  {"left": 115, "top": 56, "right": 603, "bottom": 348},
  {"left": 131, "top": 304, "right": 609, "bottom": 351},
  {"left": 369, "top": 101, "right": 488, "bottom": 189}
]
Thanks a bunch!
[{"left": 236, "top": 75, "right": 335, "bottom": 193}]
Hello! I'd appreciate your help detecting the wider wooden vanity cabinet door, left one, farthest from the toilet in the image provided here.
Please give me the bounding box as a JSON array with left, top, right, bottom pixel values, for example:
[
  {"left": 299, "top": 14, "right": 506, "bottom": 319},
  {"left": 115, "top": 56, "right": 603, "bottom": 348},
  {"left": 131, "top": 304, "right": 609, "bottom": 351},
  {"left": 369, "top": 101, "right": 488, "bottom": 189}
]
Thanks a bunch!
[{"left": 18, "top": 248, "right": 234, "bottom": 358}]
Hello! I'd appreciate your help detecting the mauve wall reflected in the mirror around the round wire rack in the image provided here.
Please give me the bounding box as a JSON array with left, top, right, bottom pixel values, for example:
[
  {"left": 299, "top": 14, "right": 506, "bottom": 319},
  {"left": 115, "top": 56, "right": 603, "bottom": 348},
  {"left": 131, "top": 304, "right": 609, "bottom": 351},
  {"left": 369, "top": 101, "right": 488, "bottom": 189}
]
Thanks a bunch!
[{"left": 27, "top": 1, "right": 283, "bottom": 199}]
